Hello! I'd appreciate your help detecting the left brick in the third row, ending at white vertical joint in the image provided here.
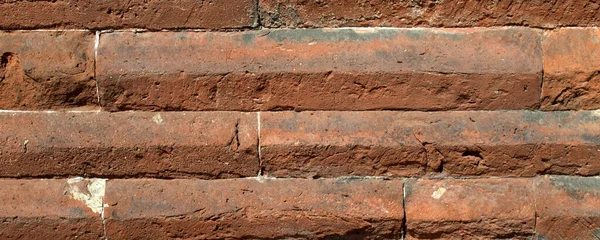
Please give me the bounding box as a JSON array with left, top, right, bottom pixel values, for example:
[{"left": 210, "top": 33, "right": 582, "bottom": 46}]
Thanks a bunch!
[{"left": 0, "top": 112, "right": 258, "bottom": 178}]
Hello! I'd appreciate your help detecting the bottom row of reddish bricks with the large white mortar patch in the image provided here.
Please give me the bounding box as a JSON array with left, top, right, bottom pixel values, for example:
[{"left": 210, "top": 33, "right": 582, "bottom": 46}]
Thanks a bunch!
[{"left": 0, "top": 176, "right": 600, "bottom": 239}]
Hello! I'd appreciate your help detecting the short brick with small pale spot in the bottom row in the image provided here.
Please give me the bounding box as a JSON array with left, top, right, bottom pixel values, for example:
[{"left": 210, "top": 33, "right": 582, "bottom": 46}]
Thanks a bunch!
[{"left": 405, "top": 178, "right": 535, "bottom": 239}]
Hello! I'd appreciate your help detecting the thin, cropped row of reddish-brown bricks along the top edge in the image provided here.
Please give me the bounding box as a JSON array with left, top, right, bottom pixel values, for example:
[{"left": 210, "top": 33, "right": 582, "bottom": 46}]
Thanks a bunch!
[{"left": 0, "top": 0, "right": 599, "bottom": 30}]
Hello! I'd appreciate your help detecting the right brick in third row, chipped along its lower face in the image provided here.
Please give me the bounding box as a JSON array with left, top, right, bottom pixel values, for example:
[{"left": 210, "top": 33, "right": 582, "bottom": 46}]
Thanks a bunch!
[{"left": 260, "top": 111, "right": 600, "bottom": 177}]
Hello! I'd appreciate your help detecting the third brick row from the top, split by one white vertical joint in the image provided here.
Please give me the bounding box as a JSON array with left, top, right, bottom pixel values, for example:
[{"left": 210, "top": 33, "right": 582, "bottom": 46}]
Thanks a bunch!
[{"left": 0, "top": 111, "right": 600, "bottom": 179}]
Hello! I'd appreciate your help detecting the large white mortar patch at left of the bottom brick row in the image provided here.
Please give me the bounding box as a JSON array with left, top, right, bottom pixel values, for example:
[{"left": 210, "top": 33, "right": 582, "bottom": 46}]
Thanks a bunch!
[{"left": 67, "top": 177, "right": 106, "bottom": 214}]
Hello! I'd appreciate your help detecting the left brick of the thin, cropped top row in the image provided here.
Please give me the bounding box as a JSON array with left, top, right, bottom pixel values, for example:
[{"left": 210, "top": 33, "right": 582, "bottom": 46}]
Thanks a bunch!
[{"left": 0, "top": 0, "right": 257, "bottom": 29}]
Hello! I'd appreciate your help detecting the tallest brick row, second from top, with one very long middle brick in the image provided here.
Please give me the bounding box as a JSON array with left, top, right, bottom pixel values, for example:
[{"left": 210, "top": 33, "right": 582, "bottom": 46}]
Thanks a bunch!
[{"left": 0, "top": 27, "right": 600, "bottom": 111}]
